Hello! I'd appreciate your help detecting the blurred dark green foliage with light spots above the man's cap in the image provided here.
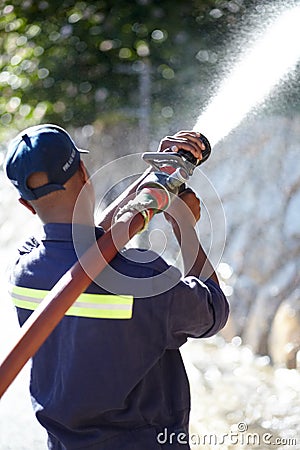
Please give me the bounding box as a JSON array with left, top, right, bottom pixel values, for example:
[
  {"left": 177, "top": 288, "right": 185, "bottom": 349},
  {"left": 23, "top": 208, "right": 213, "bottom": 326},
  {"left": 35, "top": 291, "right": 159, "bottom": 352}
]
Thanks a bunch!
[{"left": 0, "top": 0, "right": 252, "bottom": 141}]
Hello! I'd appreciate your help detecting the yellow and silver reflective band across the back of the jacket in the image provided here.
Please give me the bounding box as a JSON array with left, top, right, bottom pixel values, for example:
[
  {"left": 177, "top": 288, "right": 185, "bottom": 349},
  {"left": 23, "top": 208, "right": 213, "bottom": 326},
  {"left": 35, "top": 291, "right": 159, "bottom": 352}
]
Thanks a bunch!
[{"left": 10, "top": 286, "right": 133, "bottom": 319}]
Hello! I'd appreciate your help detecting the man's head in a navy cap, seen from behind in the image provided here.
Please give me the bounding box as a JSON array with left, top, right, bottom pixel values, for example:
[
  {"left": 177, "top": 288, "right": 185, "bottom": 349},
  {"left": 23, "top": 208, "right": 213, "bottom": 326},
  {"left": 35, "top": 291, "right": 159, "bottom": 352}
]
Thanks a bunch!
[{"left": 5, "top": 124, "right": 94, "bottom": 222}]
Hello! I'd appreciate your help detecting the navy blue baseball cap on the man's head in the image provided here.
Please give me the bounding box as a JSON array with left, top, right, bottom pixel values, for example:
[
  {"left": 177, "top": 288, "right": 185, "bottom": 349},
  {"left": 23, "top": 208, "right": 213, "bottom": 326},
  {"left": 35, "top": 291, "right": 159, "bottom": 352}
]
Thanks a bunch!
[{"left": 5, "top": 124, "right": 88, "bottom": 200}]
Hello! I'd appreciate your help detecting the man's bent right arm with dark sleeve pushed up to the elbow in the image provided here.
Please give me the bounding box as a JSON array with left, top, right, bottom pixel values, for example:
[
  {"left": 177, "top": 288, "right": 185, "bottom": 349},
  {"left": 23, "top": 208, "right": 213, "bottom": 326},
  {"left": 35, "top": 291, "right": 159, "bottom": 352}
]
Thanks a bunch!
[{"left": 165, "top": 189, "right": 229, "bottom": 348}]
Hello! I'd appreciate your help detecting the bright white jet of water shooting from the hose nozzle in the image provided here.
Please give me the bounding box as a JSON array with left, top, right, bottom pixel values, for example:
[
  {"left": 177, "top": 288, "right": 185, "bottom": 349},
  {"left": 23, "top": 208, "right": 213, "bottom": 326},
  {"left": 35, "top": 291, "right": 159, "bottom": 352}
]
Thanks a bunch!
[{"left": 194, "top": 6, "right": 300, "bottom": 146}]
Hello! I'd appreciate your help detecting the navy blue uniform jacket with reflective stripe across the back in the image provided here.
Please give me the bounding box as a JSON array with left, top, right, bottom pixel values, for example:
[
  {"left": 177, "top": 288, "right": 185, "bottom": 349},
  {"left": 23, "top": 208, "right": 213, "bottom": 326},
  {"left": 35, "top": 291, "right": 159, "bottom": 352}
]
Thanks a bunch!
[{"left": 10, "top": 224, "right": 228, "bottom": 450}]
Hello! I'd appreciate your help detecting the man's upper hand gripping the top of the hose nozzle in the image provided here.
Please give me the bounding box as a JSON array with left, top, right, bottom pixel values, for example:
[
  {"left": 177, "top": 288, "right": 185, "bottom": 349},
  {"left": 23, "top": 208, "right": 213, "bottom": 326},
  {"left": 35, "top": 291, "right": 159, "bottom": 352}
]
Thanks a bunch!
[{"left": 158, "top": 131, "right": 205, "bottom": 160}]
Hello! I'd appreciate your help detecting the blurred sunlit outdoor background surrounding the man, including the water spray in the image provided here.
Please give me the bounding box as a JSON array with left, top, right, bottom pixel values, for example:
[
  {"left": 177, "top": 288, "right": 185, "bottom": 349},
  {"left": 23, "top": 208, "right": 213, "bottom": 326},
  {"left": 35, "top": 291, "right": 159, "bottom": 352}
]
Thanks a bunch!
[{"left": 0, "top": 0, "right": 300, "bottom": 450}]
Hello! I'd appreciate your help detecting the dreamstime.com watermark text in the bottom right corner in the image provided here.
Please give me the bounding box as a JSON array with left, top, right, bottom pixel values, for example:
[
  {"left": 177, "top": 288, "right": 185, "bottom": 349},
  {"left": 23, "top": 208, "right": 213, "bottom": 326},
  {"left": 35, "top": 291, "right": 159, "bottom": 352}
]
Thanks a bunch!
[{"left": 156, "top": 422, "right": 297, "bottom": 449}]
